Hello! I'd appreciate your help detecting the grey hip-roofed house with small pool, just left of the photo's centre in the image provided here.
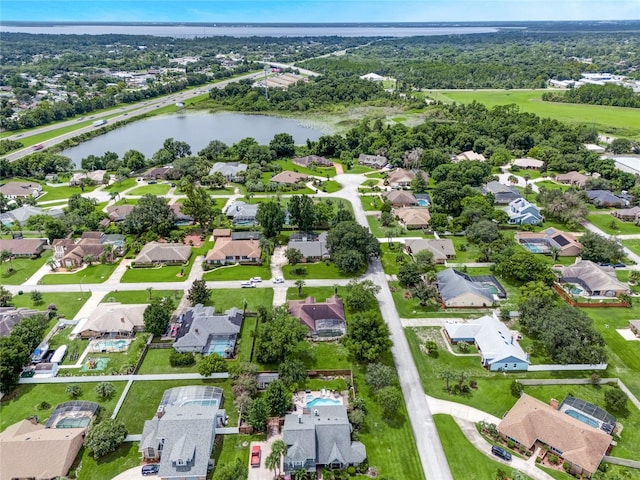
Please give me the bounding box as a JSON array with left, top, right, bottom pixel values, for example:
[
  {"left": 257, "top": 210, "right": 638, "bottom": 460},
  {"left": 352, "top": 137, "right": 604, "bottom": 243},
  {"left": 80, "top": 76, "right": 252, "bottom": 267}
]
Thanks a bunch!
[{"left": 173, "top": 303, "right": 244, "bottom": 358}]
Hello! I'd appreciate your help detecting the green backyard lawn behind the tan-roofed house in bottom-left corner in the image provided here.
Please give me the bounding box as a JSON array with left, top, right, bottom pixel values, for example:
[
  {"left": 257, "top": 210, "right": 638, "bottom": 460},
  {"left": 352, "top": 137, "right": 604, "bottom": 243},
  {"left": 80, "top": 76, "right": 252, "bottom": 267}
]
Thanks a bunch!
[{"left": 0, "top": 382, "right": 127, "bottom": 430}]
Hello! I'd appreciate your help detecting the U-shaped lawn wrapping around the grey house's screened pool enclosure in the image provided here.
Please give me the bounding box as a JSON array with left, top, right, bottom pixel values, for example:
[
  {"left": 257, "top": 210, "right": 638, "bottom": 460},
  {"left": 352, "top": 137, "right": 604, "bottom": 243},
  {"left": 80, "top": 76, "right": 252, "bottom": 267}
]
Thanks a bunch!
[{"left": 118, "top": 380, "right": 238, "bottom": 434}]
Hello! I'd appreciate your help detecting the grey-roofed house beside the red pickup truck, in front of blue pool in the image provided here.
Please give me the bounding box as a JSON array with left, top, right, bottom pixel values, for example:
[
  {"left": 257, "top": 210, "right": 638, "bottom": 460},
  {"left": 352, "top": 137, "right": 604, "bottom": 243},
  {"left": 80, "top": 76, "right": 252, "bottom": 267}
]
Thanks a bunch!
[{"left": 282, "top": 405, "right": 367, "bottom": 473}]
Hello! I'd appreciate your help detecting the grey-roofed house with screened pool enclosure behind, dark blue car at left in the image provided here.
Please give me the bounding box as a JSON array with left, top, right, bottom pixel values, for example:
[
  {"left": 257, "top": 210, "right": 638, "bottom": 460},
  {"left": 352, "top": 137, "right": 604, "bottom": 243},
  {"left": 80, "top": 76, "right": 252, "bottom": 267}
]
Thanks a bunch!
[{"left": 138, "top": 386, "right": 226, "bottom": 480}]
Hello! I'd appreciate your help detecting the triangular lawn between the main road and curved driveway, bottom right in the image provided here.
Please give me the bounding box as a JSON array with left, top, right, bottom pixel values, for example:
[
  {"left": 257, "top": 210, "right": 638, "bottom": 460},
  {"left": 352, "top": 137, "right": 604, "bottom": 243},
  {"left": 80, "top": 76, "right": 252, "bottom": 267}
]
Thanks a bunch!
[{"left": 433, "top": 414, "right": 529, "bottom": 480}]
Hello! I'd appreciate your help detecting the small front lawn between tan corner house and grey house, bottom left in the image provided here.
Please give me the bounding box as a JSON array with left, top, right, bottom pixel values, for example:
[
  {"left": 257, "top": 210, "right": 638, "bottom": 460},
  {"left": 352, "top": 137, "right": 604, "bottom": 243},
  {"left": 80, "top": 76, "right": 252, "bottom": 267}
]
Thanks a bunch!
[{"left": 71, "top": 442, "right": 142, "bottom": 480}]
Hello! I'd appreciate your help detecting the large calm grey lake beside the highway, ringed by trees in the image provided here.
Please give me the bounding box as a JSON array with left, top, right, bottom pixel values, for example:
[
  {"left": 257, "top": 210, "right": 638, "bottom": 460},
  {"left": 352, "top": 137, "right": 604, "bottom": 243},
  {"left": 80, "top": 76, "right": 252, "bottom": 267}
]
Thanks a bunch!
[{"left": 61, "top": 113, "right": 328, "bottom": 168}]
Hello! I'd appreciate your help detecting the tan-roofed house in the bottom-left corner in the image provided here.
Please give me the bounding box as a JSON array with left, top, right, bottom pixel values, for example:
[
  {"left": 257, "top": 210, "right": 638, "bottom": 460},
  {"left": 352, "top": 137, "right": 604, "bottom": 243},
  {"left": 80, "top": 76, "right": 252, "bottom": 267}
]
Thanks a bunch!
[{"left": 0, "top": 417, "right": 87, "bottom": 480}]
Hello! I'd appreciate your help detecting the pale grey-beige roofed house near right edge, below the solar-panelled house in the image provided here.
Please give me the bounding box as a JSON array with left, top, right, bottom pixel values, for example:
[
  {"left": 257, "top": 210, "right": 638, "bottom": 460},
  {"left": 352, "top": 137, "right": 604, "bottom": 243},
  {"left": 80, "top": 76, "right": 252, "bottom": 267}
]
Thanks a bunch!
[{"left": 560, "top": 260, "right": 629, "bottom": 297}]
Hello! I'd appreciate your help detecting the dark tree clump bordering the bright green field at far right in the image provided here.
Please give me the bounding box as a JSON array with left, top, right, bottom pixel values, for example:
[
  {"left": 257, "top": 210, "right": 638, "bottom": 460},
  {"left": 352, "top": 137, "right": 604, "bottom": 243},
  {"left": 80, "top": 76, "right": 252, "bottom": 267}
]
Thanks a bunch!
[{"left": 542, "top": 84, "right": 640, "bottom": 108}]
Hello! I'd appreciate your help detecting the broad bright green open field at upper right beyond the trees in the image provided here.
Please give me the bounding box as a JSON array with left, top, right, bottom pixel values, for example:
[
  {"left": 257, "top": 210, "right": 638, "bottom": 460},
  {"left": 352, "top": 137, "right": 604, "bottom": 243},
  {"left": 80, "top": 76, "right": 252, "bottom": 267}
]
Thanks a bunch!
[{"left": 438, "top": 90, "right": 640, "bottom": 139}]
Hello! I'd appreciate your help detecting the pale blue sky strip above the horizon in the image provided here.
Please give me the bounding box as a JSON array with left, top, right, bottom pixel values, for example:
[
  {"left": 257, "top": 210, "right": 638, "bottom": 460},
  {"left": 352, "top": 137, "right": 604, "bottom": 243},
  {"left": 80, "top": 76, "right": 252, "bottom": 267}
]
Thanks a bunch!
[{"left": 0, "top": 0, "right": 640, "bottom": 23}]
